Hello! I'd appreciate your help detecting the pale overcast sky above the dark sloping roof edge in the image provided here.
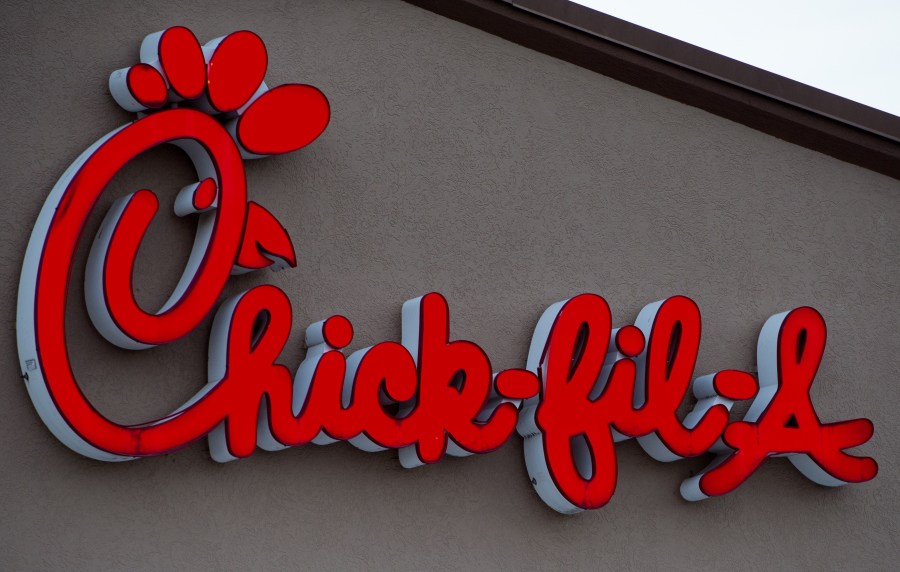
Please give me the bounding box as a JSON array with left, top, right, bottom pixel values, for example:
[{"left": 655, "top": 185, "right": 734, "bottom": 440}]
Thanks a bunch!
[{"left": 572, "top": 0, "right": 900, "bottom": 115}]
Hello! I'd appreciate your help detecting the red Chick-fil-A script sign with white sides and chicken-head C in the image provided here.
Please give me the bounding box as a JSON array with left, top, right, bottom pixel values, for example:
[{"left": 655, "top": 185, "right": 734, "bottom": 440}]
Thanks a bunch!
[{"left": 17, "top": 27, "right": 878, "bottom": 513}]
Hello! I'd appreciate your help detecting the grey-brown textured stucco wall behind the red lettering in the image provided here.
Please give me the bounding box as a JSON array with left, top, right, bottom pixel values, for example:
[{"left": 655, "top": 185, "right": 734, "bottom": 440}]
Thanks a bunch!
[{"left": 0, "top": 0, "right": 900, "bottom": 570}]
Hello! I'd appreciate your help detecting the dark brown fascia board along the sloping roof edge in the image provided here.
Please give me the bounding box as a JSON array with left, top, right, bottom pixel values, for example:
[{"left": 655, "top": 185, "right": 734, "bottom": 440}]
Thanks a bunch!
[{"left": 406, "top": 0, "right": 900, "bottom": 179}]
